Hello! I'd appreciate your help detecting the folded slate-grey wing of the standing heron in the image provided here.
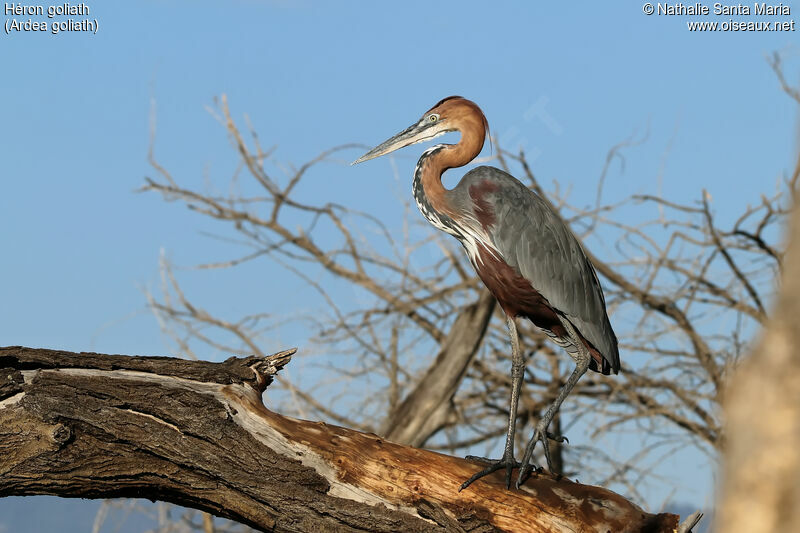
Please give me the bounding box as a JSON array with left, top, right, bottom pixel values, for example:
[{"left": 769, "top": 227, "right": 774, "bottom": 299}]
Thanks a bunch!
[{"left": 456, "top": 167, "right": 619, "bottom": 373}]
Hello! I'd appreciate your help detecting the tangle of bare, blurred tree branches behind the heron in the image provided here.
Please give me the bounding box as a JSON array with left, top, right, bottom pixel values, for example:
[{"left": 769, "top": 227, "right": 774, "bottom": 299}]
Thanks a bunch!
[{"left": 133, "top": 55, "right": 798, "bottom": 528}]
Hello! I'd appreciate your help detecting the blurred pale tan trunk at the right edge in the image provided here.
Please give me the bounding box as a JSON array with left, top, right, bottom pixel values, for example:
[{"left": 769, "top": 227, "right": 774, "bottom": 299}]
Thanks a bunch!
[{"left": 716, "top": 182, "right": 800, "bottom": 533}]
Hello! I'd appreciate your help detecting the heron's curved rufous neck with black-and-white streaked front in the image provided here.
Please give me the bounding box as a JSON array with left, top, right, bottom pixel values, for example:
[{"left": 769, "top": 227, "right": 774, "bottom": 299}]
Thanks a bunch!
[{"left": 413, "top": 120, "right": 486, "bottom": 233}]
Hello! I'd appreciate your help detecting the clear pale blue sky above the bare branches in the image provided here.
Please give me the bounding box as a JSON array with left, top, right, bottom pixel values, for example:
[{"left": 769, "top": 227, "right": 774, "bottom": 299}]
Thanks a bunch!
[{"left": 0, "top": 0, "right": 800, "bottom": 524}]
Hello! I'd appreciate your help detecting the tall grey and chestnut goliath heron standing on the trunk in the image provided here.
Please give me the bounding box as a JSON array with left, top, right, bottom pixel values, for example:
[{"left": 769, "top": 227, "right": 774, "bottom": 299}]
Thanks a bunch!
[{"left": 353, "top": 96, "right": 619, "bottom": 490}]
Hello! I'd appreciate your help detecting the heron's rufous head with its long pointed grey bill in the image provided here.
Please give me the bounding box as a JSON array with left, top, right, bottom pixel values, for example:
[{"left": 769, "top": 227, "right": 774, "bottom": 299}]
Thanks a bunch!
[{"left": 352, "top": 96, "right": 489, "bottom": 165}]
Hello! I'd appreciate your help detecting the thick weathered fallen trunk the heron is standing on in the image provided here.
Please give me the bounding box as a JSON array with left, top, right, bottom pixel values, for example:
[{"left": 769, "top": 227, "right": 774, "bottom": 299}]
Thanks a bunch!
[{"left": 0, "top": 347, "right": 678, "bottom": 533}]
